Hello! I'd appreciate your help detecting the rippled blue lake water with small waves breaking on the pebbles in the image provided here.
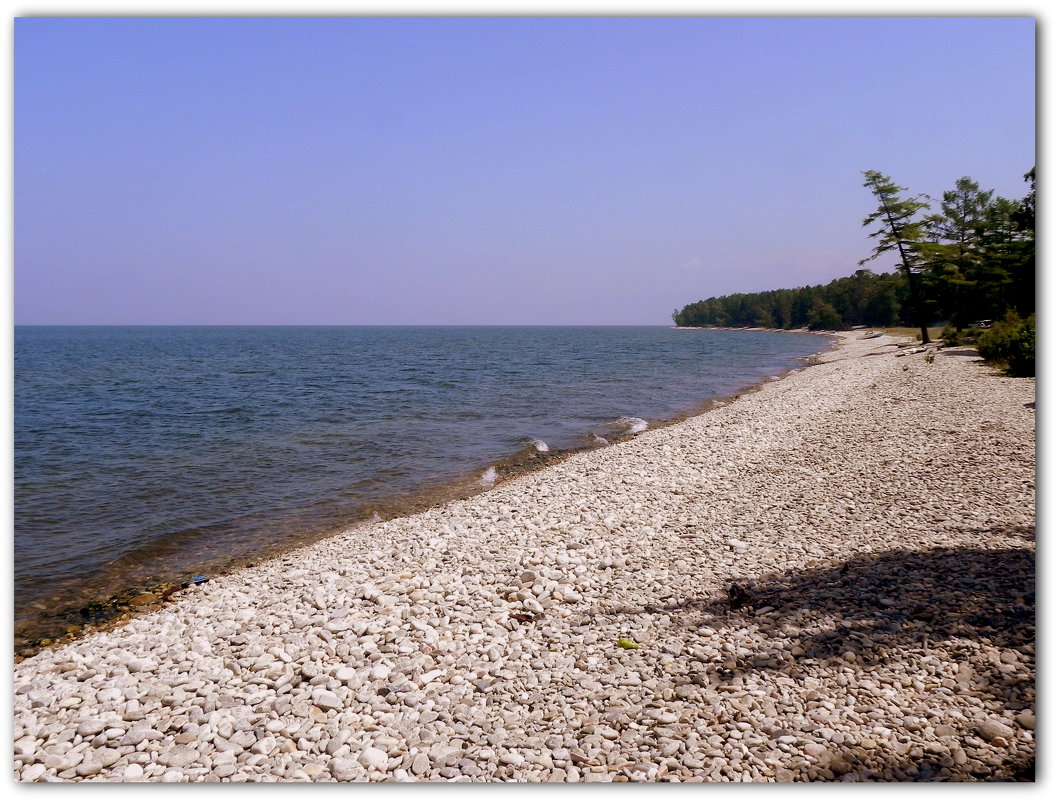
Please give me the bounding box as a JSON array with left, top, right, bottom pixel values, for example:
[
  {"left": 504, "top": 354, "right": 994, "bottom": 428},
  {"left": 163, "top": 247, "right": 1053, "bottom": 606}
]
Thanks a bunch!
[{"left": 15, "top": 327, "right": 826, "bottom": 646}]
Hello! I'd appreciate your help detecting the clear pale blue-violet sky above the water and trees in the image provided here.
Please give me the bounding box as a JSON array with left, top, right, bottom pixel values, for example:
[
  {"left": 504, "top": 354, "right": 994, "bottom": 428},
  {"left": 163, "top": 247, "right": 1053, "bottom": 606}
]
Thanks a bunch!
[{"left": 14, "top": 17, "right": 1036, "bottom": 324}]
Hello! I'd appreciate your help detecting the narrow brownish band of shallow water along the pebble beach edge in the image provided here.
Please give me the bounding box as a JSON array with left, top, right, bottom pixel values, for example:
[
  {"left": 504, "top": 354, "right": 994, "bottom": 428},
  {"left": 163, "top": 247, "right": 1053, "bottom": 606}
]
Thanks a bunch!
[{"left": 14, "top": 329, "right": 838, "bottom": 660}]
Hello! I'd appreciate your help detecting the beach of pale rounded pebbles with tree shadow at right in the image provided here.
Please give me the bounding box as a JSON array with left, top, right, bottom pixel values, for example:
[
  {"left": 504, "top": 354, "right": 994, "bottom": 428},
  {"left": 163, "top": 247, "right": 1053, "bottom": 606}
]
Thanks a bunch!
[{"left": 13, "top": 332, "right": 1036, "bottom": 782}]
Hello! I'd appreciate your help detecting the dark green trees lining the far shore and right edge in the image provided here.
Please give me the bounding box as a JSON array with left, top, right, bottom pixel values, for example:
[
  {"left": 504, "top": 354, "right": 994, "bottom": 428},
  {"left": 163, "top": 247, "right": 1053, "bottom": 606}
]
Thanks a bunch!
[{"left": 672, "top": 167, "right": 1035, "bottom": 331}]
